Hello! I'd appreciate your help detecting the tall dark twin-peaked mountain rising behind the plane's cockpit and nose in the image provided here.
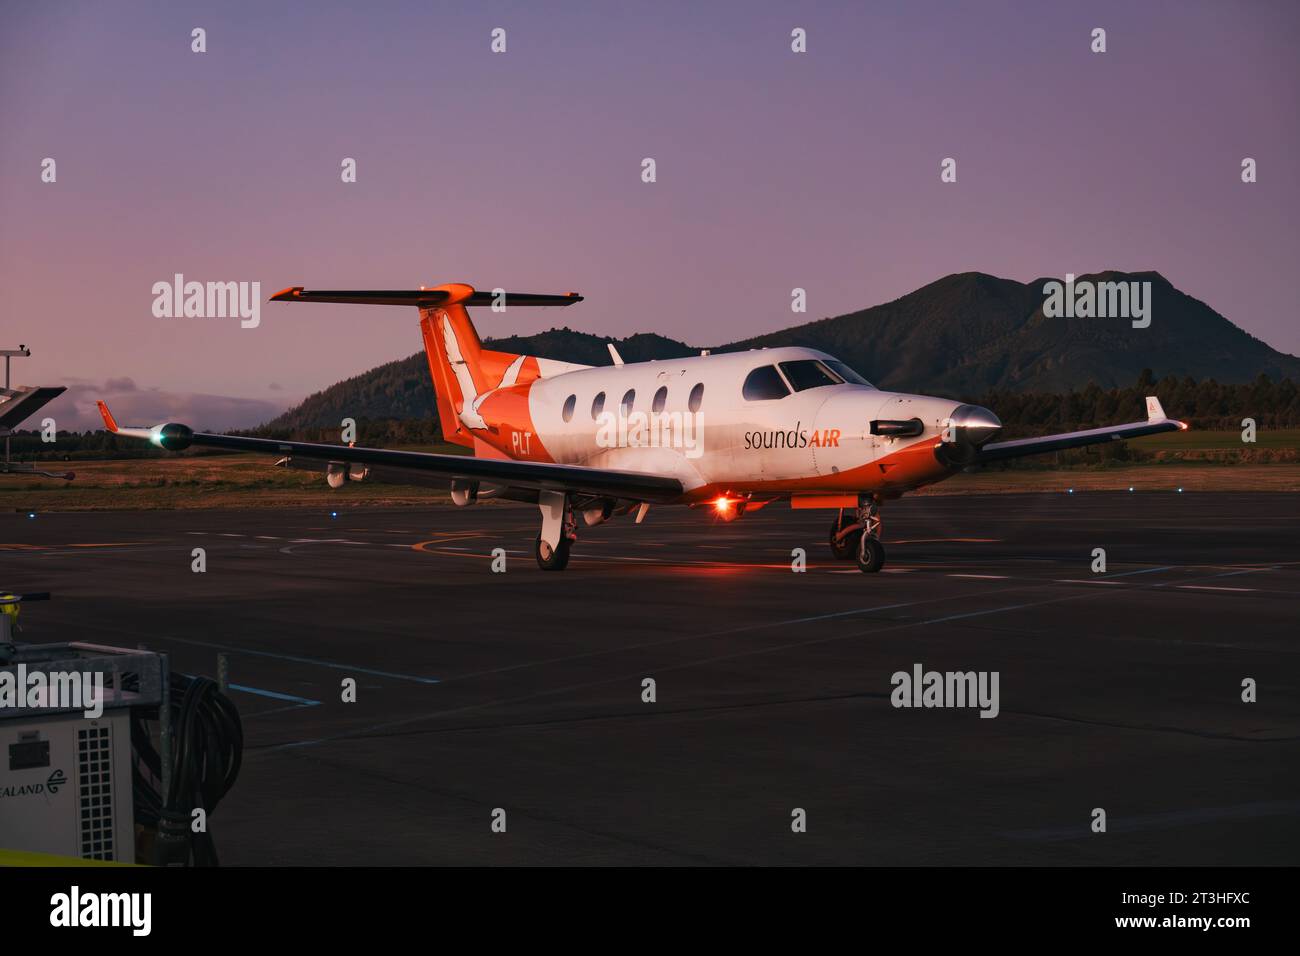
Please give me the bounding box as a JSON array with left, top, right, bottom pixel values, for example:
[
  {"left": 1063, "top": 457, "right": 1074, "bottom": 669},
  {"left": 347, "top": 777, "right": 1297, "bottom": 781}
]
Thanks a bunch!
[{"left": 725, "top": 272, "right": 1300, "bottom": 398}]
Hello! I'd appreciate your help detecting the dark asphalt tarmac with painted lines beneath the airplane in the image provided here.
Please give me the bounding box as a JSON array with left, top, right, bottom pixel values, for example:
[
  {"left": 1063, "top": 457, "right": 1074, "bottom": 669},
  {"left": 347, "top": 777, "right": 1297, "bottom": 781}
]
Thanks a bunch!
[{"left": 0, "top": 492, "right": 1300, "bottom": 865}]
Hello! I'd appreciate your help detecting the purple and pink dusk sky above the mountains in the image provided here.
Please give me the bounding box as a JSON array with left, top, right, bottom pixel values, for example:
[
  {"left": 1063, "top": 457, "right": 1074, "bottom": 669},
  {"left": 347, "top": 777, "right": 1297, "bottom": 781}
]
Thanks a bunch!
[{"left": 0, "top": 0, "right": 1300, "bottom": 428}]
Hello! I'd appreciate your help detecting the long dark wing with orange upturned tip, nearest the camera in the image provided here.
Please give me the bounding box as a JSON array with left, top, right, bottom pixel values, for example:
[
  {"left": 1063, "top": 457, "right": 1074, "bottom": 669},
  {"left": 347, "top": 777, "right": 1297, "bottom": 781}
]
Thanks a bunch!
[{"left": 98, "top": 402, "right": 685, "bottom": 502}]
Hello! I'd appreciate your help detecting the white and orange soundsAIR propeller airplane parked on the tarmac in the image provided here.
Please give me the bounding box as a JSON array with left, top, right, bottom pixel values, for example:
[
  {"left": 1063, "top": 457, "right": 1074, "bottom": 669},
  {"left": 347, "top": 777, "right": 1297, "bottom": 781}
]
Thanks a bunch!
[{"left": 98, "top": 282, "right": 1187, "bottom": 572}]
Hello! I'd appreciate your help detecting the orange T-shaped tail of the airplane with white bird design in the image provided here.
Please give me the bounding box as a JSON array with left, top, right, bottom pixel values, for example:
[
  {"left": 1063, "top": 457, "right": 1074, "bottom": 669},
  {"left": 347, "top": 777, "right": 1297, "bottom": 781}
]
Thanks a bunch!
[{"left": 270, "top": 282, "right": 582, "bottom": 449}]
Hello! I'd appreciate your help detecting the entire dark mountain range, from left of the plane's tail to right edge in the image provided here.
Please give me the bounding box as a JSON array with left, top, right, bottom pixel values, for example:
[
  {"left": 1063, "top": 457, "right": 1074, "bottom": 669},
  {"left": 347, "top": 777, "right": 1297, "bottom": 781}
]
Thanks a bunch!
[{"left": 264, "top": 272, "right": 1300, "bottom": 431}]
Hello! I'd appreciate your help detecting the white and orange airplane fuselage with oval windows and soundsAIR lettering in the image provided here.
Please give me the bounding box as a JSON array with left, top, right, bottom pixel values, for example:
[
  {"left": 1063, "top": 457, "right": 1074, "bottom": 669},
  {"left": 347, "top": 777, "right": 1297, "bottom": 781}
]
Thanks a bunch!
[{"left": 473, "top": 347, "right": 996, "bottom": 501}]
